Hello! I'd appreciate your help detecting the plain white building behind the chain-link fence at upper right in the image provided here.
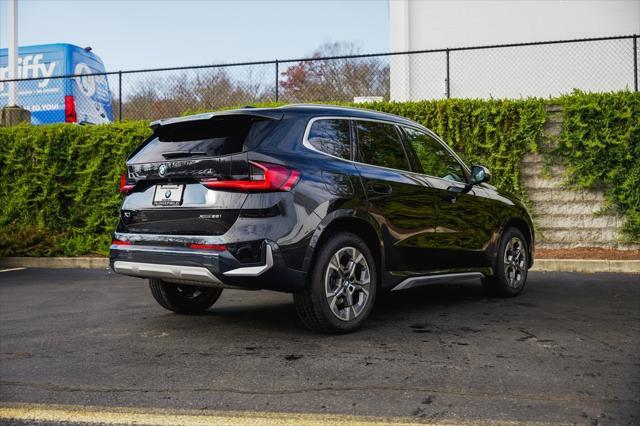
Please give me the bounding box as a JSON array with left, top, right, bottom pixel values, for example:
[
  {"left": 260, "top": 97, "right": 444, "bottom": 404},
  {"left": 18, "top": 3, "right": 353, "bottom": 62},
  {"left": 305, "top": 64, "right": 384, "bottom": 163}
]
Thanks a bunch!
[{"left": 389, "top": 0, "right": 640, "bottom": 101}]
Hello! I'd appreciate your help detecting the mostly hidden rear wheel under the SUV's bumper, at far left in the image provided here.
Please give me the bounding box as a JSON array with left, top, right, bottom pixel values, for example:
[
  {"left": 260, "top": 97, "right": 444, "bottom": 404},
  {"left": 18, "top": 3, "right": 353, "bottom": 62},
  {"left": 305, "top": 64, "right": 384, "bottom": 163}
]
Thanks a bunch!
[{"left": 149, "top": 279, "right": 222, "bottom": 314}]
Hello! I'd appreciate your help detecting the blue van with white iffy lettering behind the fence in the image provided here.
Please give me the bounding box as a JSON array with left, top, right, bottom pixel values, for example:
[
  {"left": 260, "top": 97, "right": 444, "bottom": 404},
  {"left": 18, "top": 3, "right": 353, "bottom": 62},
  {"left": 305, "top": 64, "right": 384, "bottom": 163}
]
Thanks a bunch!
[{"left": 0, "top": 43, "right": 113, "bottom": 124}]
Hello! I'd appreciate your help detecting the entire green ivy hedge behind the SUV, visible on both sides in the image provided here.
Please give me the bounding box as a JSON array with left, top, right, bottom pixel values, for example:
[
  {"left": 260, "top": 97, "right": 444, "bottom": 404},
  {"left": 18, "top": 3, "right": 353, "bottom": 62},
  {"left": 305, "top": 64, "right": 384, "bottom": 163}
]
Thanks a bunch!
[{"left": 0, "top": 92, "right": 640, "bottom": 256}]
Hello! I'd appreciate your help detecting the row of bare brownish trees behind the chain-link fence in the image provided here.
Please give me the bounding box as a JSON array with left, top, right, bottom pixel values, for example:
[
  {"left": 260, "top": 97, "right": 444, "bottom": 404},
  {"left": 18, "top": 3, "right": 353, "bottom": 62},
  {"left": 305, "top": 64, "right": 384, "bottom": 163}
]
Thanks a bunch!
[{"left": 114, "top": 42, "right": 389, "bottom": 119}]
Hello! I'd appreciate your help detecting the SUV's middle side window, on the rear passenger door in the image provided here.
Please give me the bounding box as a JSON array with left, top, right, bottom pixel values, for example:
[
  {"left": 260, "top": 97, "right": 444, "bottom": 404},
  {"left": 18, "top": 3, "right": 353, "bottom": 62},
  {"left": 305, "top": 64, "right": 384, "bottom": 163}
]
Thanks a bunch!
[{"left": 356, "top": 121, "right": 409, "bottom": 170}]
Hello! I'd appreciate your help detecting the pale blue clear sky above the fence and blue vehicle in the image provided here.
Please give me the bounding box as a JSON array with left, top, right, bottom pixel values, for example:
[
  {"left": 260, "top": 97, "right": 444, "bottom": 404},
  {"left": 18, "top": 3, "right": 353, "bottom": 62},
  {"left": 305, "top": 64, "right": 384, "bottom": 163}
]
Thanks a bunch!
[{"left": 0, "top": 0, "right": 389, "bottom": 71}]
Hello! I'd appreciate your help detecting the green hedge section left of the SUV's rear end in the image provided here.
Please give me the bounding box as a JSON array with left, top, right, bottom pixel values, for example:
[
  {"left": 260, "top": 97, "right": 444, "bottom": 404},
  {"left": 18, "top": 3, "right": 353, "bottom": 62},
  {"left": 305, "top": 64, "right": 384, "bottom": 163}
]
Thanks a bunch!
[{"left": 0, "top": 122, "right": 150, "bottom": 256}]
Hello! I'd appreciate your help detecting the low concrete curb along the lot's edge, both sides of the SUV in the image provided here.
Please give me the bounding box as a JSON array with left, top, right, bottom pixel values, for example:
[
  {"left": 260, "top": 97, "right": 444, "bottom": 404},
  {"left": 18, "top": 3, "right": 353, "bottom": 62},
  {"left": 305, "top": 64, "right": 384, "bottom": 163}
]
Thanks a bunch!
[{"left": 0, "top": 257, "right": 640, "bottom": 274}]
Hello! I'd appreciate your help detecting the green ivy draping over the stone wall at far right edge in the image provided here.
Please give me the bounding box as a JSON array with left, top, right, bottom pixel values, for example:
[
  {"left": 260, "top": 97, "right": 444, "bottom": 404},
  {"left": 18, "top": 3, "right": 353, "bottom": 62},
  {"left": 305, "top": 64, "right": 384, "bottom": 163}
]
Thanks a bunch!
[{"left": 552, "top": 91, "right": 640, "bottom": 243}]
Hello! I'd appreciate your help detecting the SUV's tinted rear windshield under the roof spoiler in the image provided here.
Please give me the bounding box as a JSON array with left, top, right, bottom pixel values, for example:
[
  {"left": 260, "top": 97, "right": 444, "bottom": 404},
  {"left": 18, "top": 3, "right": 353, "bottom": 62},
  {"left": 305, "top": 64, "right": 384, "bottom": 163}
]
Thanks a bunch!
[{"left": 129, "top": 116, "right": 270, "bottom": 163}]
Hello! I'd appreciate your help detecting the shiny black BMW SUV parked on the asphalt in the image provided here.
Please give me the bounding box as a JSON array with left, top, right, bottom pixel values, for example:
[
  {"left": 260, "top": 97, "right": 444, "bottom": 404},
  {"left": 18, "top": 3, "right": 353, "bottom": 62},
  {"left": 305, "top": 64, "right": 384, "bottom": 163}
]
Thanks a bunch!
[{"left": 110, "top": 105, "right": 534, "bottom": 333}]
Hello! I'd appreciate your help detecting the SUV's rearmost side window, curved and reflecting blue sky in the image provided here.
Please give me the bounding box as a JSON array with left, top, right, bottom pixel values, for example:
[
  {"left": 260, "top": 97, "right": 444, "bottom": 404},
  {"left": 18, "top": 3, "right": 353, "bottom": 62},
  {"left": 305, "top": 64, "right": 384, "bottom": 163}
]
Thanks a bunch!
[{"left": 307, "top": 119, "right": 351, "bottom": 160}]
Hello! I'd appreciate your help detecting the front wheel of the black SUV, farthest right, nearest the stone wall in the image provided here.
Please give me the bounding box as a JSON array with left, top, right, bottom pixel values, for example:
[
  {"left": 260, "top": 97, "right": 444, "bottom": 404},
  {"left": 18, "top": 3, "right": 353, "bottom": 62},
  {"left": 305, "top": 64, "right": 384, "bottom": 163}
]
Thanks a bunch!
[{"left": 482, "top": 228, "right": 529, "bottom": 297}]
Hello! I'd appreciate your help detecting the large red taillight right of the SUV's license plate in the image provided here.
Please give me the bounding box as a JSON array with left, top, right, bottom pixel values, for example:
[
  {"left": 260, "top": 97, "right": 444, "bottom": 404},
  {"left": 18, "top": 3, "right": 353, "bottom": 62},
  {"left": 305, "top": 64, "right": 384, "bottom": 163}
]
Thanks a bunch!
[{"left": 200, "top": 161, "right": 300, "bottom": 191}]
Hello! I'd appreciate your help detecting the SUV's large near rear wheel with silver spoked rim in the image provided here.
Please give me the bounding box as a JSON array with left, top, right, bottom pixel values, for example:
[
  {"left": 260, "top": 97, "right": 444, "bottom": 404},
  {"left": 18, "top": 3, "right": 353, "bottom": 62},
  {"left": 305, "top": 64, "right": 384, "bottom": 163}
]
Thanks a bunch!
[{"left": 293, "top": 232, "right": 378, "bottom": 334}]
